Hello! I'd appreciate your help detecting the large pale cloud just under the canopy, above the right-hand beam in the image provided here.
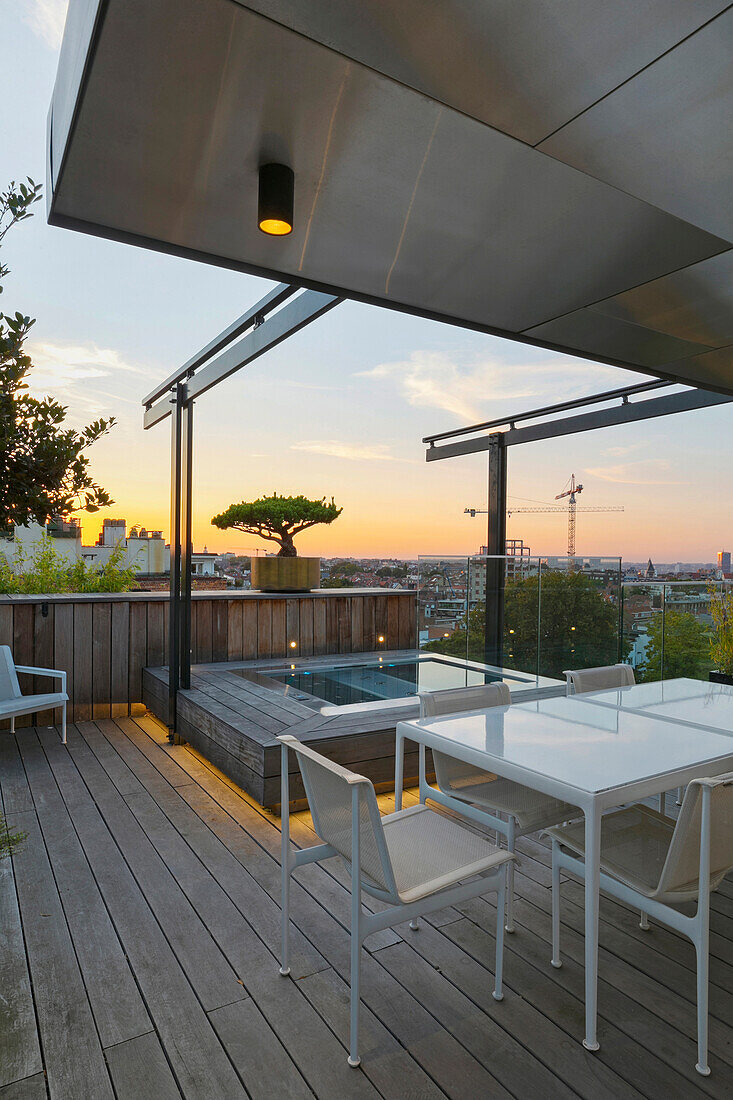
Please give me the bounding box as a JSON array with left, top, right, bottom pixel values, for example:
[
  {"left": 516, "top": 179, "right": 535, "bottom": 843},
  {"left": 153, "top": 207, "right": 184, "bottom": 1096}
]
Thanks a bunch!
[{"left": 358, "top": 351, "right": 617, "bottom": 422}]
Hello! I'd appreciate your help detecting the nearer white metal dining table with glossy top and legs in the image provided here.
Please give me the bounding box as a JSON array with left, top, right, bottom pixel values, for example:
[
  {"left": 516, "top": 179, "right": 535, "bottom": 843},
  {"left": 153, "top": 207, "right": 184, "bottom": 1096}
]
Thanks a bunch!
[{"left": 395, "top": 692, "right": 733, "bottom": 1051}]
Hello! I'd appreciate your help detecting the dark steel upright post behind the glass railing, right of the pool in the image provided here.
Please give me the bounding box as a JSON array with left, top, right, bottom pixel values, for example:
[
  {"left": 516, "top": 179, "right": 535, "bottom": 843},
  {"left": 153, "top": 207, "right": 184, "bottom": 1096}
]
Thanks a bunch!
[{"left": 484, "top": 432, "right": 506, "bottom": 668}]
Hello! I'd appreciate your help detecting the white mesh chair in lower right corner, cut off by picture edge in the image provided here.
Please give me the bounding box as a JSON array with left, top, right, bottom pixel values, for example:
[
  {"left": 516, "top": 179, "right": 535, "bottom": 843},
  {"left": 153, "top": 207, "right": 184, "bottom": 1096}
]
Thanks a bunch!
[{"left": 548, "top": 772, "right": 733, "bottom": 1077}]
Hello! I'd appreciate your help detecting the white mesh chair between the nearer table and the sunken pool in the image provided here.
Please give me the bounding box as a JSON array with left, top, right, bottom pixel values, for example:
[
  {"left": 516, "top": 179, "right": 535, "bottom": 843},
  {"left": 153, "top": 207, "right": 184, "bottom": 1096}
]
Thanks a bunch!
[{"left": 419, "top": 682, "right": 581, "bottom": 932}]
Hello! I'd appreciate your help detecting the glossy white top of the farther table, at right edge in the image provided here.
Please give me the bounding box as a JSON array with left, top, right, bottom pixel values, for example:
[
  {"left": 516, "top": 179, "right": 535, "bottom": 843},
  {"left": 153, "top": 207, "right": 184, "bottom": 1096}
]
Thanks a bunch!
[{"left": 578, "top": 679, "right": 733, "bottom": 736}]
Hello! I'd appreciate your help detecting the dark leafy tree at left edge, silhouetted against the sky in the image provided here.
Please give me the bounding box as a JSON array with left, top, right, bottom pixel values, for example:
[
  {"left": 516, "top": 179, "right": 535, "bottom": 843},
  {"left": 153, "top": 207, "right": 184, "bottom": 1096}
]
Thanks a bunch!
[{"left": 0, "top": 178, "right": 114, "bottom": 530}]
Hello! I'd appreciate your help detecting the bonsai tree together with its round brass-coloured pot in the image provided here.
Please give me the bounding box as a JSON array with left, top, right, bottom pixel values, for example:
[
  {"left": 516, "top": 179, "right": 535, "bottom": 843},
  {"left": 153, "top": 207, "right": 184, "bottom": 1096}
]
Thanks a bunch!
[{"left": 211, "top": 493, "right": 343, "bottom": 592}]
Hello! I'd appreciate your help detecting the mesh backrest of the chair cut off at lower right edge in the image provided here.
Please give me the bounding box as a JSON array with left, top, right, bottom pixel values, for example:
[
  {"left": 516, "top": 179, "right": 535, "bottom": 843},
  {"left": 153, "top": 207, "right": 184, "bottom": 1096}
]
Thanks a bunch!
[{"left": 657, "top": 772, "right": 733, "bottom": 894}]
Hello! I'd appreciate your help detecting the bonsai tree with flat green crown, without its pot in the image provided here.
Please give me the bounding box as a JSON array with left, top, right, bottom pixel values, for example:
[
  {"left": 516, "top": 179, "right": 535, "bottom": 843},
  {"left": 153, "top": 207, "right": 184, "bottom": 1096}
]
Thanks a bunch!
[{"left": 211, "top": 493, "right": 343, "bottom": 558}]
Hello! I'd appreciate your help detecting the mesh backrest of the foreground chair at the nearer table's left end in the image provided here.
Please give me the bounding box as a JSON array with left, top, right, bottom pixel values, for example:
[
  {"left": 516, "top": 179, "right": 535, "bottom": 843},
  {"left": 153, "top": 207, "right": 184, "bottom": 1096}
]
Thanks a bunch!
[{"left": 278, "top": 735, "right": 396, "bottom": 898}]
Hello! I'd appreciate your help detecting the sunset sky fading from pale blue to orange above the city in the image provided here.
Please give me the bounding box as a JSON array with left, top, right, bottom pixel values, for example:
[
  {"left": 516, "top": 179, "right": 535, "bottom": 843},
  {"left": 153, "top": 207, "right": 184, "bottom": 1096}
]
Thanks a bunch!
[{"left": 5, "top": 0, "right": 733, "bottom": 561}]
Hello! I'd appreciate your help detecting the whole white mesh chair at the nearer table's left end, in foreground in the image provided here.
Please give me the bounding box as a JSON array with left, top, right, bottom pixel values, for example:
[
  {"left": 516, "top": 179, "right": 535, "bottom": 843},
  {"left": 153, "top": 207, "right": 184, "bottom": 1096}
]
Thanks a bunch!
[{"left": 278, "top": 735, "right": 514, "bottom": 1066}]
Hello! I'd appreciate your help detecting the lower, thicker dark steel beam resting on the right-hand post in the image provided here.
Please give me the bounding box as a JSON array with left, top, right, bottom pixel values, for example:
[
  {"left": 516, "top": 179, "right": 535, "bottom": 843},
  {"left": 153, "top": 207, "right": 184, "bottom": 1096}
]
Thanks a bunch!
[{"left": 425, "top": 389, "right": 733, "bottom": 462}]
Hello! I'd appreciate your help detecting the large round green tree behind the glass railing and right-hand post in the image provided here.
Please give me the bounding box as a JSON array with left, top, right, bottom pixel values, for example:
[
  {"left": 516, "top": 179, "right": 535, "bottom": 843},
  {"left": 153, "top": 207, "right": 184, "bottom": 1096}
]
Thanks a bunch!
[{"left": 426, "top": 570, "right": 619, "bottom": 678}]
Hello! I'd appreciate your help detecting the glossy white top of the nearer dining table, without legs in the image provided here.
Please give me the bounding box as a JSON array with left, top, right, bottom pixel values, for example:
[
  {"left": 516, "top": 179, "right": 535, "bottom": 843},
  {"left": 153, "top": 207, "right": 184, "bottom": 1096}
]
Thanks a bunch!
[{"left": 401, "top": 697, "right": 733, "bottom": 794}]
